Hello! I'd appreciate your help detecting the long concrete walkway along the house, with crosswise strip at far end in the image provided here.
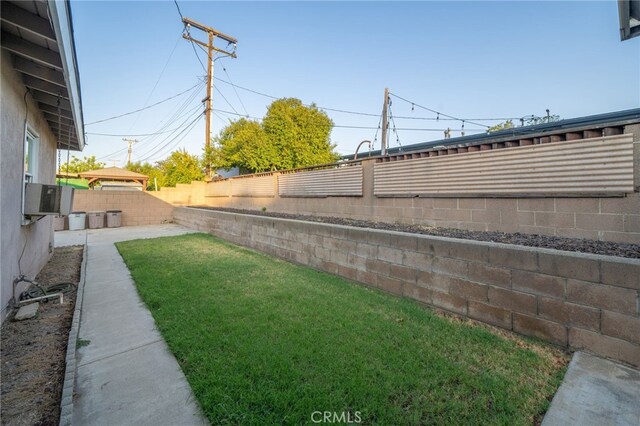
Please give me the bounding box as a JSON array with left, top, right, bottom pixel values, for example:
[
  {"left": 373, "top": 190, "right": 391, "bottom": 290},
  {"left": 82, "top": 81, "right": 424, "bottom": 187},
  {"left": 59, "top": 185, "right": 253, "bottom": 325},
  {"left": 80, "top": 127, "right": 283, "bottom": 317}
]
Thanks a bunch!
[{"left": 55, "top": 225, "right": 207, "bottom": 425}]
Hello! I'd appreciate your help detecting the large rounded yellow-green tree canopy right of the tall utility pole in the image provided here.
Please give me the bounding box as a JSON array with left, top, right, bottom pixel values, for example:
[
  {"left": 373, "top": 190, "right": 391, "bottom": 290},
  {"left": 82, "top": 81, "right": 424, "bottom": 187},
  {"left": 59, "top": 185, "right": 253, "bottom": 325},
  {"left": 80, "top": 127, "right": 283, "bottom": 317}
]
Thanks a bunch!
[{"left": 205, "top": 98, "right": 339, "bottom": 172}]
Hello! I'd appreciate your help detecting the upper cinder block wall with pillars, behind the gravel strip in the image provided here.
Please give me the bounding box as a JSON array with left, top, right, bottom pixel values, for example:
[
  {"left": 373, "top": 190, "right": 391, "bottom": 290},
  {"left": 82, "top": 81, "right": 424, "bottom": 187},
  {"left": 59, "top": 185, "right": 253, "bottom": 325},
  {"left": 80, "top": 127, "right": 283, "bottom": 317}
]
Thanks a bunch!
[{"left": 194, "top": 124, "right": 640, "bottom": 244}]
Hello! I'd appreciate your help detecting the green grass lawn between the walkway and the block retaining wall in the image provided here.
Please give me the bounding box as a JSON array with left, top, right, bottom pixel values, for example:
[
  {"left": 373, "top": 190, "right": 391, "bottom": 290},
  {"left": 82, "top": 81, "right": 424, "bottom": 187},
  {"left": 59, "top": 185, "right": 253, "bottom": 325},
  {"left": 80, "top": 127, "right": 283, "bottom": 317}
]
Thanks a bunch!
[{"left": 117, "top": 234, "right": 566, "bottom": 425}]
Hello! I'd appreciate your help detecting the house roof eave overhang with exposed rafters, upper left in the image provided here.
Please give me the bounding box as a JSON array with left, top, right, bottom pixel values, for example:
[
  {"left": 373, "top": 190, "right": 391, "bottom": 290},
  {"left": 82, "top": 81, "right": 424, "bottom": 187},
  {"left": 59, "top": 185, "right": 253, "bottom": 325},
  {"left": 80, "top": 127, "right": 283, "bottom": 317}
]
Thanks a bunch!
[{"left": 0, "top": 0, "right": 85, "bottom": 151}]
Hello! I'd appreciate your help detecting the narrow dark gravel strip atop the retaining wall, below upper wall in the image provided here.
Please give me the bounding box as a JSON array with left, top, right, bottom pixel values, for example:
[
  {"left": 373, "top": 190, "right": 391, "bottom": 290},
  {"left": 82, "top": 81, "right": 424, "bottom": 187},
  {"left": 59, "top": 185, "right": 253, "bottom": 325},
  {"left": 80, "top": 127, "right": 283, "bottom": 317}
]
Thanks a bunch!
[{"left": 191, "top": 206, "right": 640, "bottom": 259}]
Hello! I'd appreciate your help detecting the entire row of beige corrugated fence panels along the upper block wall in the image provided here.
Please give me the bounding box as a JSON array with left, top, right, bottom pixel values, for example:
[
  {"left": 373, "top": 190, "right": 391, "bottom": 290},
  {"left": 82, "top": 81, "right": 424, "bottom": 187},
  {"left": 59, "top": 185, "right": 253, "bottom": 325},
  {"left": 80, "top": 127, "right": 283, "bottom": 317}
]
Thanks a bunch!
[{"left": 206, "top": 134, "right": 634, "bottom": 197}]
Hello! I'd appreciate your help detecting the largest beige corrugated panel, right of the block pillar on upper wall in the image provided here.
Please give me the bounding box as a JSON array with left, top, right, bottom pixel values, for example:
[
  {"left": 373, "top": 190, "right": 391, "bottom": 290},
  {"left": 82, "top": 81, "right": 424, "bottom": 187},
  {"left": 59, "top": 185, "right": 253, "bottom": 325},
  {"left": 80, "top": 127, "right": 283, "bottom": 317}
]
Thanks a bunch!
[{"left": 374, "top": 135, "right": 633, "bottom": 197}]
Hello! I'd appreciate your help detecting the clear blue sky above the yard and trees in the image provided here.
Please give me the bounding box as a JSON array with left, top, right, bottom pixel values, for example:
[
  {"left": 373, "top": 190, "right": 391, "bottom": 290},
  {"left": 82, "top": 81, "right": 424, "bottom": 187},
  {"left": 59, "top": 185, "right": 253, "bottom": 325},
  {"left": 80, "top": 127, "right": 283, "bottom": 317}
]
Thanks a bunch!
[{"left": 71, "top": 0, "right": 640, "bottom": 166}]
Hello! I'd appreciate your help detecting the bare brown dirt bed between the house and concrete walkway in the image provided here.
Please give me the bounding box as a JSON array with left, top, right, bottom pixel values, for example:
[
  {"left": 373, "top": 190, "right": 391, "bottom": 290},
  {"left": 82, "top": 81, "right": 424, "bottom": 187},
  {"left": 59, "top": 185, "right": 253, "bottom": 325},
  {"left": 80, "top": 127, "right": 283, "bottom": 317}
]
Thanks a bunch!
[{"left": 0, "top": 246, "right": 83, "bottom": 425}]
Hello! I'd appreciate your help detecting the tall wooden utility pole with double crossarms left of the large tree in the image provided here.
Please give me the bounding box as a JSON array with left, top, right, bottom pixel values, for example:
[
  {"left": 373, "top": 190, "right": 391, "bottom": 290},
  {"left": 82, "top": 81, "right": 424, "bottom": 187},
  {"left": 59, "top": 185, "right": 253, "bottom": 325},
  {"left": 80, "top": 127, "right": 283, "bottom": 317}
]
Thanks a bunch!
[{"left": 182, "top": 18, "right": 238, "bottom": 175}]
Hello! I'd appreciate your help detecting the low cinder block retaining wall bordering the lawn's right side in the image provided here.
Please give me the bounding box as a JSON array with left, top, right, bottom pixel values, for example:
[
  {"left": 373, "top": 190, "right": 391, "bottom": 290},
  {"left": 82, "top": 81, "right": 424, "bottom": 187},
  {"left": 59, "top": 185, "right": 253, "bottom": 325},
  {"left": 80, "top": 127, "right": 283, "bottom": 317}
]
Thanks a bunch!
[{"left": 174, "top": 207, "right": 640, "bottom": 365}]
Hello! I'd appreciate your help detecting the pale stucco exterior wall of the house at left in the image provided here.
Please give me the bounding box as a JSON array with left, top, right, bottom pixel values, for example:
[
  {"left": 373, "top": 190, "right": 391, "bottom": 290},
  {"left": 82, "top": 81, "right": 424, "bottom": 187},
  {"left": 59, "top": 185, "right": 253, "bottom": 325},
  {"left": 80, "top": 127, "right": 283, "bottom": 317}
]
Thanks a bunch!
[{"left": 0, "top": 50, "right": 56, "bottom": 321}]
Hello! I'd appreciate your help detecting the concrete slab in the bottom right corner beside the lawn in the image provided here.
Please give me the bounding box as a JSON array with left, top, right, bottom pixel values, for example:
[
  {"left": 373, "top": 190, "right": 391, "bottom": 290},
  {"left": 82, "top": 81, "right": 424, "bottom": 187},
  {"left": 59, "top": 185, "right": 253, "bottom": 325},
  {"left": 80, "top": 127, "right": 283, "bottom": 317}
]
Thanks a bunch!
[{"left": 542, "top": 352, "right": 640, "bottom": 426}]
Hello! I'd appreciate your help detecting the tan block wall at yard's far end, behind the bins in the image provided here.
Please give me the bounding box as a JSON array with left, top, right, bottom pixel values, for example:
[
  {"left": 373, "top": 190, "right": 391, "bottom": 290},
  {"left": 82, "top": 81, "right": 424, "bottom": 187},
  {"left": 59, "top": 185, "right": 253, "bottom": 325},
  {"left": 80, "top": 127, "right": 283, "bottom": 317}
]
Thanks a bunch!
[{"left": 73, "top": 190, "right": 174, "bottom": 226}]
